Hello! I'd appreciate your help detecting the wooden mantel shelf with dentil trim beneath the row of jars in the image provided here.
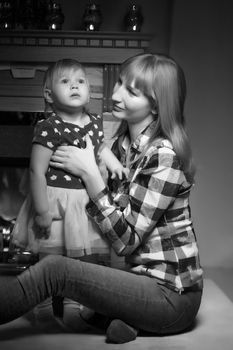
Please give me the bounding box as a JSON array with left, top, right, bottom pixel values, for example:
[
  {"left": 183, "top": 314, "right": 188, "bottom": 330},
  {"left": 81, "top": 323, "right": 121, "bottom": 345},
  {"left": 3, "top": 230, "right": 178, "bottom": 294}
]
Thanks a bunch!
[{"left": 0, "top": 30, "right": 152, "bottom": 64}]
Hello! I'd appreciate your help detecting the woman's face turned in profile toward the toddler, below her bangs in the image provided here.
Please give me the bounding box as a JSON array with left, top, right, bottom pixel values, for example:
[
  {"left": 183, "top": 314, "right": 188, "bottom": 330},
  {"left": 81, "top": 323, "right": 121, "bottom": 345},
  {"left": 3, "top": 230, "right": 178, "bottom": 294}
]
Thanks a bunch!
[{"left": 112, "top": 78, "right": 153, "bottom": 124}]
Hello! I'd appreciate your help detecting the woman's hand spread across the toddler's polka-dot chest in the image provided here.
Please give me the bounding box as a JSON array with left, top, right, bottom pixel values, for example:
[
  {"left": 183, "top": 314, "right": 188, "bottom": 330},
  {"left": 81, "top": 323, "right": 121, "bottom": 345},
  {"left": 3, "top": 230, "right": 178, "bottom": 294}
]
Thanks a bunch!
[{"left": 49, "top": 135, "right": 97, "bottom": 178}]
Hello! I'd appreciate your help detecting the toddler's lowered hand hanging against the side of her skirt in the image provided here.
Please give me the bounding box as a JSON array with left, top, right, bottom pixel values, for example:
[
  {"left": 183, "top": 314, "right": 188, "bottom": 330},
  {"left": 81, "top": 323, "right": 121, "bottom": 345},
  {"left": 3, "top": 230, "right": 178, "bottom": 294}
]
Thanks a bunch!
[{"left": 33, "top": 212, "right": 53, "bottom": 239}]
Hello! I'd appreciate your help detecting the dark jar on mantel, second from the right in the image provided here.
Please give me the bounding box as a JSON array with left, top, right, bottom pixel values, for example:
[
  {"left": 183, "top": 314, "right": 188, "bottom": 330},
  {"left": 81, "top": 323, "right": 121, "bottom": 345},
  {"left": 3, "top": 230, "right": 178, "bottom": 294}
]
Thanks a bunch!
[{"left": 83, "top": 2, "right": 102, "bottom": 31}]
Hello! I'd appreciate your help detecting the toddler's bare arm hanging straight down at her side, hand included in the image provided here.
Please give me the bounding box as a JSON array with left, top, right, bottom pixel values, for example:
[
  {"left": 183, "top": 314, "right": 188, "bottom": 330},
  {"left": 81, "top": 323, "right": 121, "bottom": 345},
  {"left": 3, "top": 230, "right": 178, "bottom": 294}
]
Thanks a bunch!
[{"left": 30, "top": 143, "right": 53, "bottom": 238}]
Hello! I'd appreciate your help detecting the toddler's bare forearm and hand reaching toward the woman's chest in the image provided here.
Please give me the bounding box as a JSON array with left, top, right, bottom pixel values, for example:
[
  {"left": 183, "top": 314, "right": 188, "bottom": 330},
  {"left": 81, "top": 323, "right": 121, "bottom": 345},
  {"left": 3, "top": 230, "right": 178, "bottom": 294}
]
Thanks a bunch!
[{"left": 99, "top": 145, "right": 129, "bottom": 180}]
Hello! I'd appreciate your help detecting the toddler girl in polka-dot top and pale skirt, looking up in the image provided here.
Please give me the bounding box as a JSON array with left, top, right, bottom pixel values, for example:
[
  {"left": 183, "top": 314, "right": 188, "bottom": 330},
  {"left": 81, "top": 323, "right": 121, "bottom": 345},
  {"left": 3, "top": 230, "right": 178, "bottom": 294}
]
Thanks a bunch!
[{"left": 12, "top": 59, "right": 127, "bottom": 330}]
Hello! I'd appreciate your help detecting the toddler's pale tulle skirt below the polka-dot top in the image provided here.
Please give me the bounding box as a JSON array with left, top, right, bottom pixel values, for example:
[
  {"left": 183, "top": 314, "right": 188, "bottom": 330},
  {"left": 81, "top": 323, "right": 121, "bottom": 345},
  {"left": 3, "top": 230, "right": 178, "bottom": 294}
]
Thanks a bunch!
[{"left": 12, "top": 186, "right": 110, "bottom": 258}]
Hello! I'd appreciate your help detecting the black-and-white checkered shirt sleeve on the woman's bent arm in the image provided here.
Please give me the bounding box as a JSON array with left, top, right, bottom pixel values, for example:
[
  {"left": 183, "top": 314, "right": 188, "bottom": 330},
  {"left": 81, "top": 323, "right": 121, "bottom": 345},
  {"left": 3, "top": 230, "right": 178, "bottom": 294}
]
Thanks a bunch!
[{"left": 87, "top": 146, "right": 184, "bottom": 255}]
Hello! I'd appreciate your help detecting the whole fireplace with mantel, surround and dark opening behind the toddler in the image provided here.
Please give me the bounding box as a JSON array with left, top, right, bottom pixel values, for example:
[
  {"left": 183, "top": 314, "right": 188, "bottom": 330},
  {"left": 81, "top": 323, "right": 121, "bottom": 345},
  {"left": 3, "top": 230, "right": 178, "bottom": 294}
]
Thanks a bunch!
[{"left": 0, "top": 31, "right": 151, "bottom": 271}]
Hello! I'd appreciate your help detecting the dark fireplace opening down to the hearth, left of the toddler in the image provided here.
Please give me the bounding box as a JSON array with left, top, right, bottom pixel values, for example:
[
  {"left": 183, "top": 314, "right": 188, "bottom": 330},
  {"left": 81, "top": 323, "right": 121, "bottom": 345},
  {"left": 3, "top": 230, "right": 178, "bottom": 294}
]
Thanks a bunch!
[{"left": 0, "top": 111, "right": 42, "bottom": 274}]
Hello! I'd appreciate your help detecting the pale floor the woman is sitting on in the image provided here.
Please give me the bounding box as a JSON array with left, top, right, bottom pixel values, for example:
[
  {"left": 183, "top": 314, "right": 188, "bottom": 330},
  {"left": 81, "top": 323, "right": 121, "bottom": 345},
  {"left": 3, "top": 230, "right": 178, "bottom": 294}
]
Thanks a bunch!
[{"left": 0, "top": 269, "right": 233, "bottom": 350}]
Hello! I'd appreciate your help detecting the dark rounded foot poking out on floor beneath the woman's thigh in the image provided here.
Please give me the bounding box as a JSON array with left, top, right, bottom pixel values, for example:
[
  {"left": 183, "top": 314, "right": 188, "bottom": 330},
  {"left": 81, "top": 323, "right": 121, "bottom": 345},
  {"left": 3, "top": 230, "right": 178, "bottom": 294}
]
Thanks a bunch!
[{"left": 106, "top": 319, "right": 138, "bottom": 344}]
